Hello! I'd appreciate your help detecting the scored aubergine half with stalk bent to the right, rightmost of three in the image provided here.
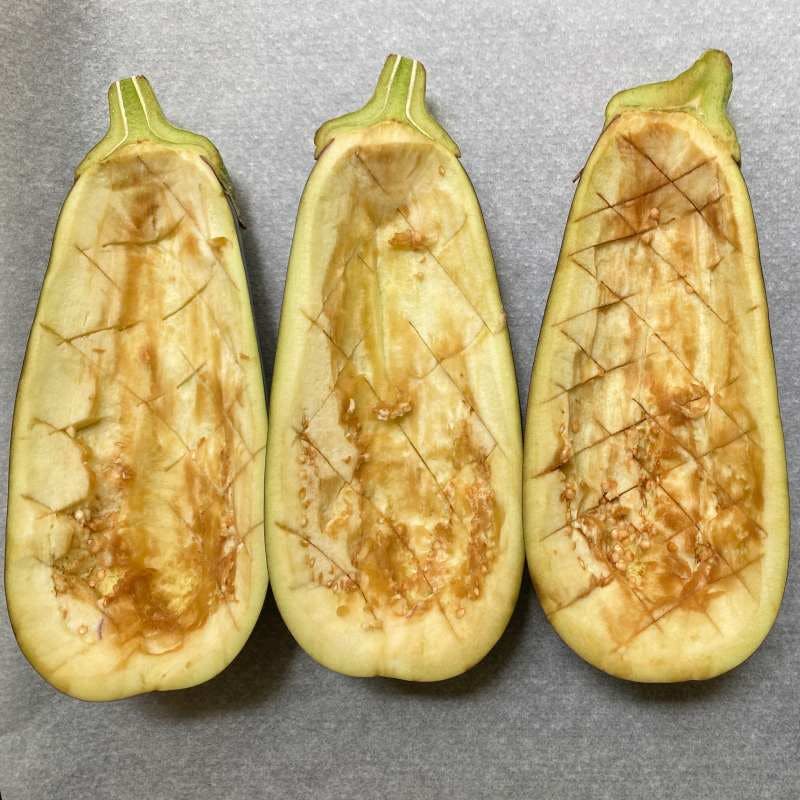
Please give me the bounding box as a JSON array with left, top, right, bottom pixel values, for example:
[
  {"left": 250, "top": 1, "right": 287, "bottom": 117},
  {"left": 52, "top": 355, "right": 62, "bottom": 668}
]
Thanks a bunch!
[{"left": 525, "top": 51, "right": 789, "bottom": 681}]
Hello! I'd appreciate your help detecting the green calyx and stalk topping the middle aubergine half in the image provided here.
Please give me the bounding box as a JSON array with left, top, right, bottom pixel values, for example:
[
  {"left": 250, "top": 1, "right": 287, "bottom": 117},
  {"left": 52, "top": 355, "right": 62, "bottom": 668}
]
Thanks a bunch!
[{"left": 314, "top": 55, "right": 461, "bottom": 158}]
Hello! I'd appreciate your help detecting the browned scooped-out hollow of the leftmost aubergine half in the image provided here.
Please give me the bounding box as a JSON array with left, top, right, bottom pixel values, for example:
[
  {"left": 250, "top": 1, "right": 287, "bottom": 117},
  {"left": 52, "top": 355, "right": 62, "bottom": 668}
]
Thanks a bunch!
[{"left": 45, "top": 149, "right": 252, "bottom": 653}]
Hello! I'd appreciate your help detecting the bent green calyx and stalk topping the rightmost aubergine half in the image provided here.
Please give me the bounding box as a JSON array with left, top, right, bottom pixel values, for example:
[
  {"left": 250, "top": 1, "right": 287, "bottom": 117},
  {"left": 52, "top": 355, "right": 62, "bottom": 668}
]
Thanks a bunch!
[{"left": 605, "top": 50, "right": 741, "bottom": 162}]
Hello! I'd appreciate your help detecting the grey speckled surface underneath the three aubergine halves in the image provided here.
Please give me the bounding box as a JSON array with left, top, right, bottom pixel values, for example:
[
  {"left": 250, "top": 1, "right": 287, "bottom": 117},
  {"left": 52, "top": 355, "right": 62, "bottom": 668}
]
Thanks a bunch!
[{"left": 0, "top": 0, "right": 800, "bottom": 800}]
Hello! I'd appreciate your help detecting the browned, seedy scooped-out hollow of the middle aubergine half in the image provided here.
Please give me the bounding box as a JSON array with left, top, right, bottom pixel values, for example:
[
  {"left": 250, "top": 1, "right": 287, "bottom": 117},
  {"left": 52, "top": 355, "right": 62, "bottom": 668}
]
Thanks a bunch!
[{"left": 282, "top": 133, "right": 504, "bottom": 629}]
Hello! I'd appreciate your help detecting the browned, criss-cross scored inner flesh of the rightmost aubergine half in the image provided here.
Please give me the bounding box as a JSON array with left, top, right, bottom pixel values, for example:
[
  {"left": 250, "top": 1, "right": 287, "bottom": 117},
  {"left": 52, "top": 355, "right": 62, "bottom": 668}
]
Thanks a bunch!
[{"left": 545, "top": 114, "right": 766, "bottom": 648}]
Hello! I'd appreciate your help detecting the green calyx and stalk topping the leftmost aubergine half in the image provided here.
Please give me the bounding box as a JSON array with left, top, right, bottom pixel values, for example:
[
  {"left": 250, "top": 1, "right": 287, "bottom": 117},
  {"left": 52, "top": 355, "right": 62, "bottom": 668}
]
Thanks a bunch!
[{"left": 75, "top": 75, "right": 236, "bottom": 209}]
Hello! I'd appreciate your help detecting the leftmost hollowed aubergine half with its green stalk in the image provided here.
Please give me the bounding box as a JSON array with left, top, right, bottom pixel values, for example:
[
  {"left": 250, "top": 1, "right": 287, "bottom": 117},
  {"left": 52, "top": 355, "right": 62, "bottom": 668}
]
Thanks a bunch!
[{"left": 5, "top": 77, "right": 267, "bottom": 700}]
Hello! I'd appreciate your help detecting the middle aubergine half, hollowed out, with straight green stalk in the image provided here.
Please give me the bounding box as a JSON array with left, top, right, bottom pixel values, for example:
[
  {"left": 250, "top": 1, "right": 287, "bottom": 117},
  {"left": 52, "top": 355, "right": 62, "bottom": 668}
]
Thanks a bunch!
[{"left": 267, "top": 56, "right": 524, "bottom": 681}]
